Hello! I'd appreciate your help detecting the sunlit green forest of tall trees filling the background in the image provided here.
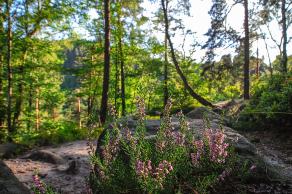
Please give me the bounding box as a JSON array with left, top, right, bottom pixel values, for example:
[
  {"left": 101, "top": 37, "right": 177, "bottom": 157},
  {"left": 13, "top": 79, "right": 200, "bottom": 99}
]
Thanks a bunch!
[{"left": 0, "top": 0, "right": 292, "bottom": 141}]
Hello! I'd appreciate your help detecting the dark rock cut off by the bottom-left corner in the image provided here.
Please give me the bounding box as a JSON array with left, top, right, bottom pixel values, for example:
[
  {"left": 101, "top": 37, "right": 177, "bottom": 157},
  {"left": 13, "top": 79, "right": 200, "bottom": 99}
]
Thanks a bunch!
[{"left": 0, "top": 160, "right": 30, "bottom": 194}]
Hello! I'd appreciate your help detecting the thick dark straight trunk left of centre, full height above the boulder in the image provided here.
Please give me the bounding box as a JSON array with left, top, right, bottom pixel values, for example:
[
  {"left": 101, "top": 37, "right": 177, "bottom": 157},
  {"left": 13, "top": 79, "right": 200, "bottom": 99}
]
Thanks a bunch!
[{"left": 100, "top": 0, "right": 110, "bottom": 124}]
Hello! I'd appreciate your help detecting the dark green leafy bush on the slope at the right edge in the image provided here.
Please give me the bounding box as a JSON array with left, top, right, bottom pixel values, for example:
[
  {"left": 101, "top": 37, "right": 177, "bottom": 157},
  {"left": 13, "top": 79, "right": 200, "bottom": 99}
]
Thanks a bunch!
[{"left": 236, "top": 73, "right": 292, "bottom": 129}]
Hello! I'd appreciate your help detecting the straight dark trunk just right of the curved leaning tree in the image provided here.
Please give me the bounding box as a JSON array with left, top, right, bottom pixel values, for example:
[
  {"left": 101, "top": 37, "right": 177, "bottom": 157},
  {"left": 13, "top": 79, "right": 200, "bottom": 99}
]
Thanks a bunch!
[{"left": 243, "top": 0, "right": 249, "bottom": 100}]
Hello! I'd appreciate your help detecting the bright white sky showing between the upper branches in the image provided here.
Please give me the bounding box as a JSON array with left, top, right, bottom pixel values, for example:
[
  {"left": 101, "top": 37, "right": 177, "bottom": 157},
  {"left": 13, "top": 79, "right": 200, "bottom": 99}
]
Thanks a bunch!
[{"left": 78, "top": 0, "right": 292, "bottom": 63}]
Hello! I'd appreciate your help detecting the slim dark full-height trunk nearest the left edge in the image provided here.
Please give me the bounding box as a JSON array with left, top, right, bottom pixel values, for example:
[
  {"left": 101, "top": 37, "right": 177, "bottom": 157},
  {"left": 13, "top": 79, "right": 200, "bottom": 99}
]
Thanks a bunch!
[{"left": 6, "top": 0, "right": 14, "bottom": 141}]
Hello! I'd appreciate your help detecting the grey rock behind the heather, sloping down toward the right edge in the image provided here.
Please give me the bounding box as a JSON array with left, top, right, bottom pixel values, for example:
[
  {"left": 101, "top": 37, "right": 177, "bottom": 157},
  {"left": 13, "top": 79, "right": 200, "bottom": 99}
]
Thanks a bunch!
[{"left": 117, "top": 108, "right": 292, "bottom": 182}]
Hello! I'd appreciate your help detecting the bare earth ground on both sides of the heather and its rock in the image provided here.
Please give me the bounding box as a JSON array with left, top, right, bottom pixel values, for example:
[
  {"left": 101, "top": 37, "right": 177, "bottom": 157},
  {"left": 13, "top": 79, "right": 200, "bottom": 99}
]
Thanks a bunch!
[{"left": 5, "top": 131, "right": 292, "bottom": 194}]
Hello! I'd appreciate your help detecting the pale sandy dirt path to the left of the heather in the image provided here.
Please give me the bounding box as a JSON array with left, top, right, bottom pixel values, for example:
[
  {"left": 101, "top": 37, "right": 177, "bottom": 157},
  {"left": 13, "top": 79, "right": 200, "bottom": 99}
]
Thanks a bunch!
[{"left": 4, "top": 141, "right": 91, "bottom": 194}]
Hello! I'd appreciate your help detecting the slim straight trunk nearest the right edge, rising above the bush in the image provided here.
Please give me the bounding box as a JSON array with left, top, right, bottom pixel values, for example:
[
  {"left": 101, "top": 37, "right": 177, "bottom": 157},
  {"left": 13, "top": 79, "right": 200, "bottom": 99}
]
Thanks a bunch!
[{"left": 281, "top": 0, "right": 288, "bottom": 73}]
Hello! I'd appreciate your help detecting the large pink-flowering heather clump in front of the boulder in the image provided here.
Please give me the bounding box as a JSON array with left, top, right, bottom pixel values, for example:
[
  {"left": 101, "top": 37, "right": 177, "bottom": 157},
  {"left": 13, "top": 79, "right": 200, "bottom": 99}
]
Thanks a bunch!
[{"left": 89, "top": 99, "right": 241, "bottom": 193}]
